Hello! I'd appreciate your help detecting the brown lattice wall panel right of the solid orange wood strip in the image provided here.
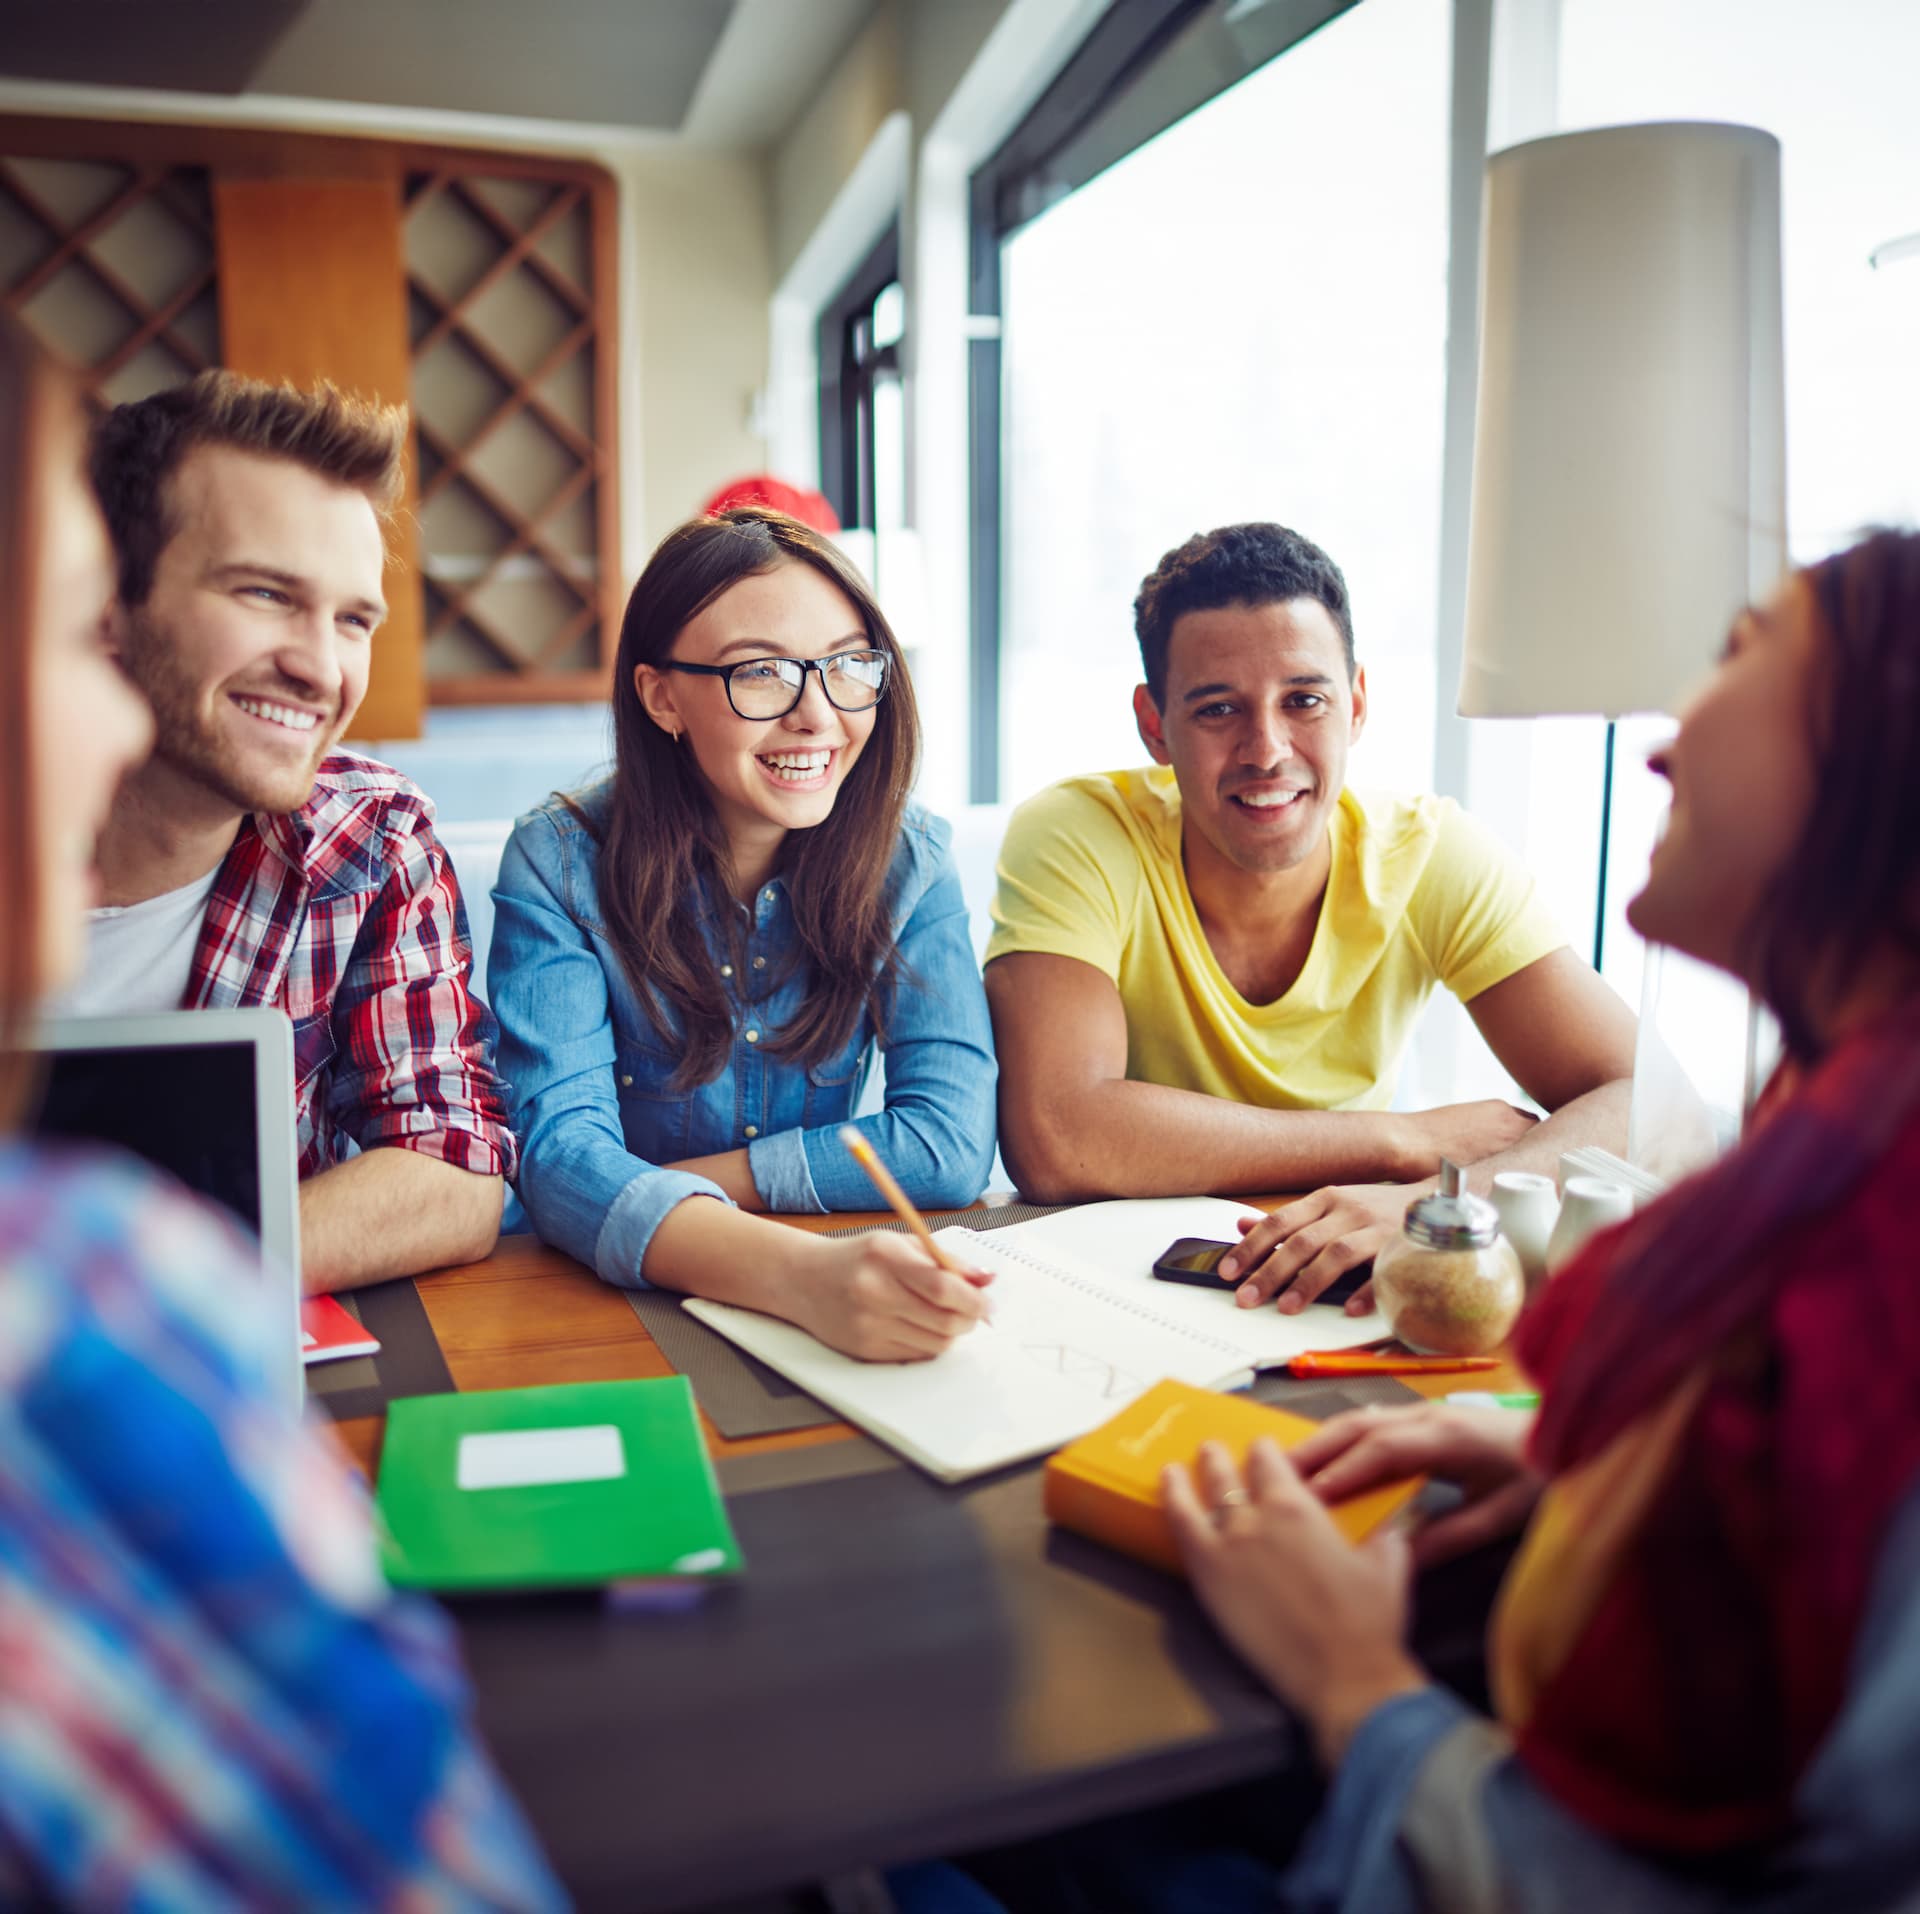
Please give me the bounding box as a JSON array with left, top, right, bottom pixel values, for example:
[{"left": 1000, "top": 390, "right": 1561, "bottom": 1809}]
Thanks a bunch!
[{"left": 407, "top": 169, "right": 614, "bottom": 703}]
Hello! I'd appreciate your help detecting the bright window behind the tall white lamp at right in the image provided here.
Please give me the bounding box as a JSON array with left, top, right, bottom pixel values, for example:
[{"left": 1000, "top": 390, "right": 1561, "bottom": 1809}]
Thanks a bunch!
[{"left": 1489, "top": 0, "right": 1920, "bottom": 1121}]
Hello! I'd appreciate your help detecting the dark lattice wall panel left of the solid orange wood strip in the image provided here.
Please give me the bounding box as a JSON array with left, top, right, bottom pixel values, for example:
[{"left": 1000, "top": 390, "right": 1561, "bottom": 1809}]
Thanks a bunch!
[{"left": 0, "top": 157, "right": 221, "bottom": 405}]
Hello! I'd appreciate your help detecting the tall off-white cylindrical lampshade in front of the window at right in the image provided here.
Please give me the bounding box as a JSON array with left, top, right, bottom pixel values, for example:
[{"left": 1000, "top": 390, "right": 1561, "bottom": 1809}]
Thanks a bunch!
[{"left": 1459, "top": 125, "right": 1786, "bottom": 718}]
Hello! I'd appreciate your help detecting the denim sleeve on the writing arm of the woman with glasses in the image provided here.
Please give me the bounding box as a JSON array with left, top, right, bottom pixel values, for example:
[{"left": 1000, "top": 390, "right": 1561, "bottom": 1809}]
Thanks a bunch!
[{"left": 488, "top": 812, "right": 730, "bottom": 1288}]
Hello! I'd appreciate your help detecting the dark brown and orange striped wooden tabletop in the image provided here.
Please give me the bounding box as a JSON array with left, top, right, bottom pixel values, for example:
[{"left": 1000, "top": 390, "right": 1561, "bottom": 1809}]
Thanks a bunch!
[{"left": 338, "top": 1215, "right": 1517, "bottom": 1914}]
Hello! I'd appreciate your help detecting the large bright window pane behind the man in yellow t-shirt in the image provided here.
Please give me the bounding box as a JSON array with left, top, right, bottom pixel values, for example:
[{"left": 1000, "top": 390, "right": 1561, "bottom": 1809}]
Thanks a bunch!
[{"left": 975, "top": 0, "right": 1450, "bottom": 799}]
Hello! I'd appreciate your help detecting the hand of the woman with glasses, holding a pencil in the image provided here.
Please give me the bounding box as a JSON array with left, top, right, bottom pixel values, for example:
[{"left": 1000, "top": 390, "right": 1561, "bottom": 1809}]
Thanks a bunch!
[{"left": 775, "top": 1125, "right": 993, "bottom": 1363}]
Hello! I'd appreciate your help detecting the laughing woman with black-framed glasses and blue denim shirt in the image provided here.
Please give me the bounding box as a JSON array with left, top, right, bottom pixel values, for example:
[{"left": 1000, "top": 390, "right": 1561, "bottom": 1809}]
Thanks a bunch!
[{"left": 490, "top": 507, "right": 995, "bottom": 1361}]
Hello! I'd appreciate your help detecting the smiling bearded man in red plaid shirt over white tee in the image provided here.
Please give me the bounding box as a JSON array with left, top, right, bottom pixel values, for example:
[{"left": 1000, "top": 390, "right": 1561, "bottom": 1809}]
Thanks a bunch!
[{"left": 60, "top": 372, "right": 515, "bottom": 1290}]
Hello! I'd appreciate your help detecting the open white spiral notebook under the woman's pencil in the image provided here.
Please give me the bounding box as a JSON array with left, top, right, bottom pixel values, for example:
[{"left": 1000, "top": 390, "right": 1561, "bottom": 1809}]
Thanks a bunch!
[{"left": 687, "top": 1196, "right": 1388, "bottom": 1482}]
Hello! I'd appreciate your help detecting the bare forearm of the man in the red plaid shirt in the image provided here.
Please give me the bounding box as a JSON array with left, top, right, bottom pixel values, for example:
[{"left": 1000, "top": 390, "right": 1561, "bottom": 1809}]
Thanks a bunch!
[{"left": 300, "top": 1146, "right": 505, "bottom": 1294}]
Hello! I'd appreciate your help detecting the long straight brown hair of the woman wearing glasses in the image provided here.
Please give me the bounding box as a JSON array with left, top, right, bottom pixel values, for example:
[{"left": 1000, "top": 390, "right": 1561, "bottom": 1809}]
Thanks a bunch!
[{"left": 599, "top": 507, "right": 920, "bottom": 1089}]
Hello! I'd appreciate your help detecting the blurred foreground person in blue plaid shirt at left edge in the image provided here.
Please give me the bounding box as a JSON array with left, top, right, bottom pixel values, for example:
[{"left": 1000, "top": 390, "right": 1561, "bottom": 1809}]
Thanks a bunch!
[{"left": 0, "top": 324, "right": 563, "bottom": 1914}]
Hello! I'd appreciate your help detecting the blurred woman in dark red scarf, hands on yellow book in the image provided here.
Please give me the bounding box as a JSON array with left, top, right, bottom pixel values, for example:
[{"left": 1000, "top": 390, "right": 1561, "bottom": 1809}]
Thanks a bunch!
[{"left": 1136, "top": 534, "right": 1920, "bottom": 1914}]
